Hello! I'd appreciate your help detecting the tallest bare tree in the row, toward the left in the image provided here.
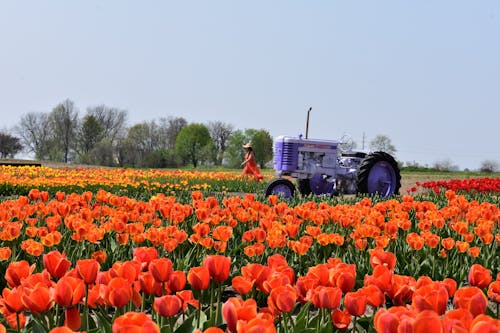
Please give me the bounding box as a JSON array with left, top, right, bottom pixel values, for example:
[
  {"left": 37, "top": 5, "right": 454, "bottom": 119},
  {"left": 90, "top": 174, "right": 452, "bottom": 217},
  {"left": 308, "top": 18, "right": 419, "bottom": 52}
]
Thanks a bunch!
[{"left": 49, "top": 99, "right": 78, "bottom": 163}]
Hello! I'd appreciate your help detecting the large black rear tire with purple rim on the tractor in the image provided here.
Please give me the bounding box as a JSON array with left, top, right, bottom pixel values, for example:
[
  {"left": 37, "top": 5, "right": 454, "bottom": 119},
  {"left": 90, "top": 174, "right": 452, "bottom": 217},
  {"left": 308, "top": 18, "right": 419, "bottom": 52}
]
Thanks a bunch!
[{"left": 356, "top": 151, "right": 401, "bottom": 196}]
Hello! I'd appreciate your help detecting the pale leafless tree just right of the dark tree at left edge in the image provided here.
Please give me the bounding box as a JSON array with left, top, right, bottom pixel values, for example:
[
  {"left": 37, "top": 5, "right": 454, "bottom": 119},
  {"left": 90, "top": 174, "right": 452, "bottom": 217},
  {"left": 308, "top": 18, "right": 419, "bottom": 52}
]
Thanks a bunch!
[{"left": 14, "top": 112, "right": 51, "bottom": 161}]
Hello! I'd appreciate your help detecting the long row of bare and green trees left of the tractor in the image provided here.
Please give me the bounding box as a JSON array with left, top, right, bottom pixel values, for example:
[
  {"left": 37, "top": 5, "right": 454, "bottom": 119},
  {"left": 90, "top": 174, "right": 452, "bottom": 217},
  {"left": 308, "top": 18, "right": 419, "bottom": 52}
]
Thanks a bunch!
[{"left": 0, "top": 99, "right": 273, "bottom": 168}]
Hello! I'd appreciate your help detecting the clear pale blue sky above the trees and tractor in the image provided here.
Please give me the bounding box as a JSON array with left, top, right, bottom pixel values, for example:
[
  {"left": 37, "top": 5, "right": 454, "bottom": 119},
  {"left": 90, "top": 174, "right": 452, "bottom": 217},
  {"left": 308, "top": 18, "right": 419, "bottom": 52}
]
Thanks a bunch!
[{"left": 0, "top": 0, "right": 500, "bottom": 169}]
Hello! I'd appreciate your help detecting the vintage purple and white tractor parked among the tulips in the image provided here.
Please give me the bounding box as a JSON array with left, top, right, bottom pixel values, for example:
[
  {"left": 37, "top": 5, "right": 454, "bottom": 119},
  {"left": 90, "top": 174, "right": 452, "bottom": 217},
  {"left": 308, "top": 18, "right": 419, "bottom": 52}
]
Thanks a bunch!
[{"left": 266, "top": 136, "right": 401, "bottom": 198}]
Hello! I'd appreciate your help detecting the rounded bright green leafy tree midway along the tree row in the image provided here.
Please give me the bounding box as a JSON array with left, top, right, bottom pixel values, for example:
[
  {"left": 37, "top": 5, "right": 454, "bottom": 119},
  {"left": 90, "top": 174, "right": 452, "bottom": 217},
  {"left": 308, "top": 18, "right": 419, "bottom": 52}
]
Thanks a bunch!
[{"left": 175, "top": 124, "right": 212, "bottom": 168}]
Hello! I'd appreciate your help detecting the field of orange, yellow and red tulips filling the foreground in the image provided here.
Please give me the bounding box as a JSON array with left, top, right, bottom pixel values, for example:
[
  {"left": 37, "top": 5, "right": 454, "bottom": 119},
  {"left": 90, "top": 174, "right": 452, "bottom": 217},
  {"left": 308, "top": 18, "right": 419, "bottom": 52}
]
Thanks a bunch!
[{"left": 0, "top": 166, "right": 500, "bottom": 333}]
